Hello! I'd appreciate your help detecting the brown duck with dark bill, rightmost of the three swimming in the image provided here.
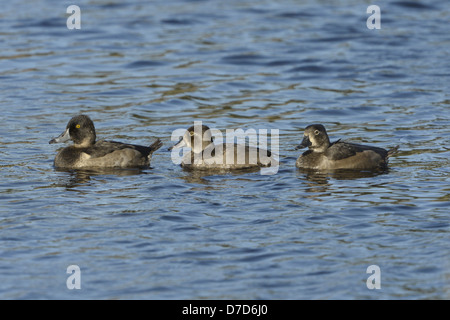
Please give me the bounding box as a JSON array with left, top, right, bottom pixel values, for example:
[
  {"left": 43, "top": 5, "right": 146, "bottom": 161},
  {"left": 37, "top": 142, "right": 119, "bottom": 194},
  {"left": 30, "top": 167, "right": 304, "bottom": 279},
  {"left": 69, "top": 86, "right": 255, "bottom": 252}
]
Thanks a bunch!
[{"left": 295, "top": 124, "right": 399, "bottom": 170}]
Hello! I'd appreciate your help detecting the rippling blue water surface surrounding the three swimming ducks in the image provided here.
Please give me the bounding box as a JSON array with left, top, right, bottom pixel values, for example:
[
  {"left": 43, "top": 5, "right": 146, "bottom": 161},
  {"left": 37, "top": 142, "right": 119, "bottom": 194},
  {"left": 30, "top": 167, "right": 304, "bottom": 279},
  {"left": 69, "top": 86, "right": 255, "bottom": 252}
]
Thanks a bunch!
[{"left": 0, "top": 0, "right": 450, "bottom": 299}]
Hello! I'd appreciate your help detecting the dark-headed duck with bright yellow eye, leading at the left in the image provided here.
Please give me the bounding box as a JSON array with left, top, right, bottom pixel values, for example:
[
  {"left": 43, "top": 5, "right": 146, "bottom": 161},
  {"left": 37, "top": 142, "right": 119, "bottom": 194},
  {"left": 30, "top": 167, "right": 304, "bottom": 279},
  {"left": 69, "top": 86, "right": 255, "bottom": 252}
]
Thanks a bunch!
[{"left": 49, "top": 114, "right": 162, "bottom": 169}]
